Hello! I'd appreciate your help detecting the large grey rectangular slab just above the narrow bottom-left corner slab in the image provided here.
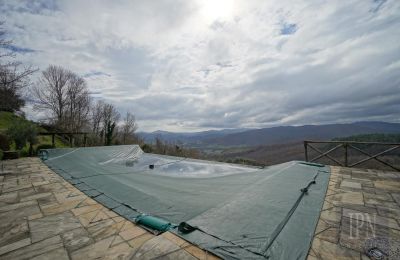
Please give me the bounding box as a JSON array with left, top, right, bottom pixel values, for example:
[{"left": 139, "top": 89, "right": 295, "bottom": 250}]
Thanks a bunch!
[{"left": 29, "top": 212, "right": 81, "bottom": 243}]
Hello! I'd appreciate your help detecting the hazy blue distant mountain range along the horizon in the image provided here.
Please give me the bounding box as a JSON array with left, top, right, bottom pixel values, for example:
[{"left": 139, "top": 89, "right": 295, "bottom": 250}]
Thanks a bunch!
[{"left": 139, "top": 122, "right": 400, "bottom": 147}]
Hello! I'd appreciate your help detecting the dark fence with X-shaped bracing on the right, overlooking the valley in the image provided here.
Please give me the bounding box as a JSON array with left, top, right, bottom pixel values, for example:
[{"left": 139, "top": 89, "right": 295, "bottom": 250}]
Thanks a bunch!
[{"left": 304, "top": 141, "right": 400, "bottom": 171}]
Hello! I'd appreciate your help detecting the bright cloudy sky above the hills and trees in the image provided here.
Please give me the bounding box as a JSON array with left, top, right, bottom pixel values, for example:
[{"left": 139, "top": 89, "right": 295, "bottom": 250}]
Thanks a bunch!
[{"left": 0, "top": 0, "right": 400, "bottom": 131}]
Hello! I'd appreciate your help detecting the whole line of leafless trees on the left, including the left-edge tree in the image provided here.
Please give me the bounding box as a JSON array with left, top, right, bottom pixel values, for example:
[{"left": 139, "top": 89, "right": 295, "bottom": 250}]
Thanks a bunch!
[{"left": 0, "top": 22, "right": 139, "bottom": 148}]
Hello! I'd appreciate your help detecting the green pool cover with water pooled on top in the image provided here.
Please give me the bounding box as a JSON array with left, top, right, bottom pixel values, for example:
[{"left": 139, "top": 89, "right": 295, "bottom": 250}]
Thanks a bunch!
[{"left": 41, "top": 145, "right": 330, "bottom": 259}]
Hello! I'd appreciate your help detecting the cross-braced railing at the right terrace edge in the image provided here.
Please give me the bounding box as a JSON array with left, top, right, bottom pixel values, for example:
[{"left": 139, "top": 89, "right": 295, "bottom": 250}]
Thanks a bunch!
[{"left": 304, "top": 141, "right": 400, "bottom": 171}]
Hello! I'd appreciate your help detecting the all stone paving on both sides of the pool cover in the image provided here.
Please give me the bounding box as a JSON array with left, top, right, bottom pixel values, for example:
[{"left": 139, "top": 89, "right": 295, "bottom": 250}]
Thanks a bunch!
[{"left": 0, "top": 158, "right": 400, "bottom": 260}]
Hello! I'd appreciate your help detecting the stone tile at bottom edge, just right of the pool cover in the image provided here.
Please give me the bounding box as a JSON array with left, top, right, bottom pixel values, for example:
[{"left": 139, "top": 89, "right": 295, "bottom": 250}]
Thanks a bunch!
[{"left": 311, "top": 238, "right": 360, "bottom": 260}]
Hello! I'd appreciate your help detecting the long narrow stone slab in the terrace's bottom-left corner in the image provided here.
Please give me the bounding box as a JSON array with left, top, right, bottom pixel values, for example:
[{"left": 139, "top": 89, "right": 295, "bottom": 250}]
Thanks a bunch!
[{"left": 1, "top": 236, "right": 63, "bottom": 260}]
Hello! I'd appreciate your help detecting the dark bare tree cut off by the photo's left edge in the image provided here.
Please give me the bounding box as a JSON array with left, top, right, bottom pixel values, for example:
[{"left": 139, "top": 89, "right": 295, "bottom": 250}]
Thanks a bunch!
[{"left": 0, "top": 21, "right": 37, "bottom": 112}]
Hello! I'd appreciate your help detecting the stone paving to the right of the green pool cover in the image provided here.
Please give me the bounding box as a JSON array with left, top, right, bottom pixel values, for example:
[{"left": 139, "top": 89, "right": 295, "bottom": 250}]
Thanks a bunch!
[{"left": 308, "top": 166, "right": 400, "bottom": 259}]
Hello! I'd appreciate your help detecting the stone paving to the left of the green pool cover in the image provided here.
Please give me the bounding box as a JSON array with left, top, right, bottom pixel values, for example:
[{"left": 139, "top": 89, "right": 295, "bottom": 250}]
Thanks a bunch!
[{"left": 0, "top": 158, "right": 218, "bottom": 260}]
